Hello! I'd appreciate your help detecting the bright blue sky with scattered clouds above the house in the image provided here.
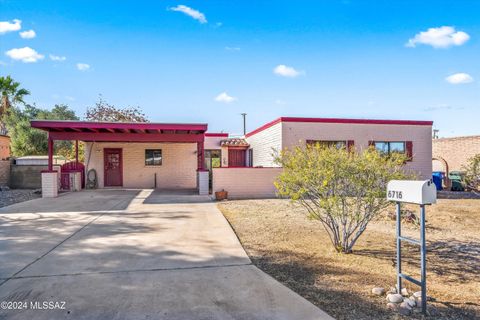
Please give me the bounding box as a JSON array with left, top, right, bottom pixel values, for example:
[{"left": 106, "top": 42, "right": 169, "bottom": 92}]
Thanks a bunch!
[{"left": 0, "top": 0, "right": 480, "bottom": 136}]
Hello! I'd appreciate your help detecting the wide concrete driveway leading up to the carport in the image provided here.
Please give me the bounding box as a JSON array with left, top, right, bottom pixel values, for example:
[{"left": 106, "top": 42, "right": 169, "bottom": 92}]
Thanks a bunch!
[{"left": 0, "top": 190, "right": 331, "bottom": 320}]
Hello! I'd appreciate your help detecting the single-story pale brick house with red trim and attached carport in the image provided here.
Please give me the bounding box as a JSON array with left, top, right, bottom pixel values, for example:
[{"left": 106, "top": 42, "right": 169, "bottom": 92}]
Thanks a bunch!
[{"left": 31, "top": 117, "right": 432, "bottom": 197}]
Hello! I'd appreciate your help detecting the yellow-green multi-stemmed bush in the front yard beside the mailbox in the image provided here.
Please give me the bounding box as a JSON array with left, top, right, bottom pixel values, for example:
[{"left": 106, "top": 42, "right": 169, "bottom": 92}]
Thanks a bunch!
[{"left": 275, "top": 144, "right": 407, "bottom": 253}]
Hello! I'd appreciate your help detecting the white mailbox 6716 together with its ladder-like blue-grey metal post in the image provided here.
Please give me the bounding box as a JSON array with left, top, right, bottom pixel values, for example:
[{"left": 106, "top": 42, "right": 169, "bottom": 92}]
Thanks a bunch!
[{"left": 387, "top": 180, "right": 437, "bottom": 314}]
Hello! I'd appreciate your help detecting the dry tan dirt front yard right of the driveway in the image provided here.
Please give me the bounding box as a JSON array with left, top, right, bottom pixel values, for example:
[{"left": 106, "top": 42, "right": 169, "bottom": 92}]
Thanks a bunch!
[{"left": 218, "top": 199, "right": 480, "bottom": 319}]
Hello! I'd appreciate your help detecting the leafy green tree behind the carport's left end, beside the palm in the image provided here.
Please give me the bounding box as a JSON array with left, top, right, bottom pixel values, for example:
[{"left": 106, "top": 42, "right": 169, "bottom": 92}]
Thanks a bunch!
[{"left": 4, "top": 104, "right": 81, "bottom": 159}]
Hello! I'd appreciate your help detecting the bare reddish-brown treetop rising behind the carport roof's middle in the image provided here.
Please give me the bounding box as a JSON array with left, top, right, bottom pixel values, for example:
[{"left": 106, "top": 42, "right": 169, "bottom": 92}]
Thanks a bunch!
[{"left": 85, "top": 96, "right": 148, "bottom": 122}]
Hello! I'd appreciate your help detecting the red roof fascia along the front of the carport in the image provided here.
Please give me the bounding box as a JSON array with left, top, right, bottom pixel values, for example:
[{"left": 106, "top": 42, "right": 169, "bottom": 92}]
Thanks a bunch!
[{"left": 30, "top": 120, "right": 208, "bottom": 133}]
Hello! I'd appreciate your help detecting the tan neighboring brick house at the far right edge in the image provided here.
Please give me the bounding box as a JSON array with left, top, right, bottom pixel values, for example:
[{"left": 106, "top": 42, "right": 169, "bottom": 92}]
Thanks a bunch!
[{"left": 432, "top": 136, "right": 480, "bottom": 173}]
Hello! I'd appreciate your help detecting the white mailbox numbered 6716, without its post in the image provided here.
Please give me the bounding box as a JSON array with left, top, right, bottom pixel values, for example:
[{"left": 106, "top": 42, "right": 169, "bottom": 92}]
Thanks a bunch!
[{"left": 387, "top": 180, "right": 437, "bottom": 204}]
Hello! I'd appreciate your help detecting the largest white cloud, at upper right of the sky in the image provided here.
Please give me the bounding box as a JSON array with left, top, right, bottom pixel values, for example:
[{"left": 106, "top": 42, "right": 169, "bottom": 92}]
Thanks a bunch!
[{"left": 406, "top": 26, "right": 470, "bottom": 48}]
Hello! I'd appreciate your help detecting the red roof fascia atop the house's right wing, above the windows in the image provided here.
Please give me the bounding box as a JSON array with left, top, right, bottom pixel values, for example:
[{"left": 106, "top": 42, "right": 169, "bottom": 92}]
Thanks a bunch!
[{"left": 245, "top": 117, "right": 433, "bottom": 138}]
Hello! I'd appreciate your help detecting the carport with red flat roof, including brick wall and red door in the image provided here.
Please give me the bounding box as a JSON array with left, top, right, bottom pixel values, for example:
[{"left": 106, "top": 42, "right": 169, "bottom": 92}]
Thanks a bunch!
[{"left": 31, "top": 120, "right": 208, "bottom": 197}]
